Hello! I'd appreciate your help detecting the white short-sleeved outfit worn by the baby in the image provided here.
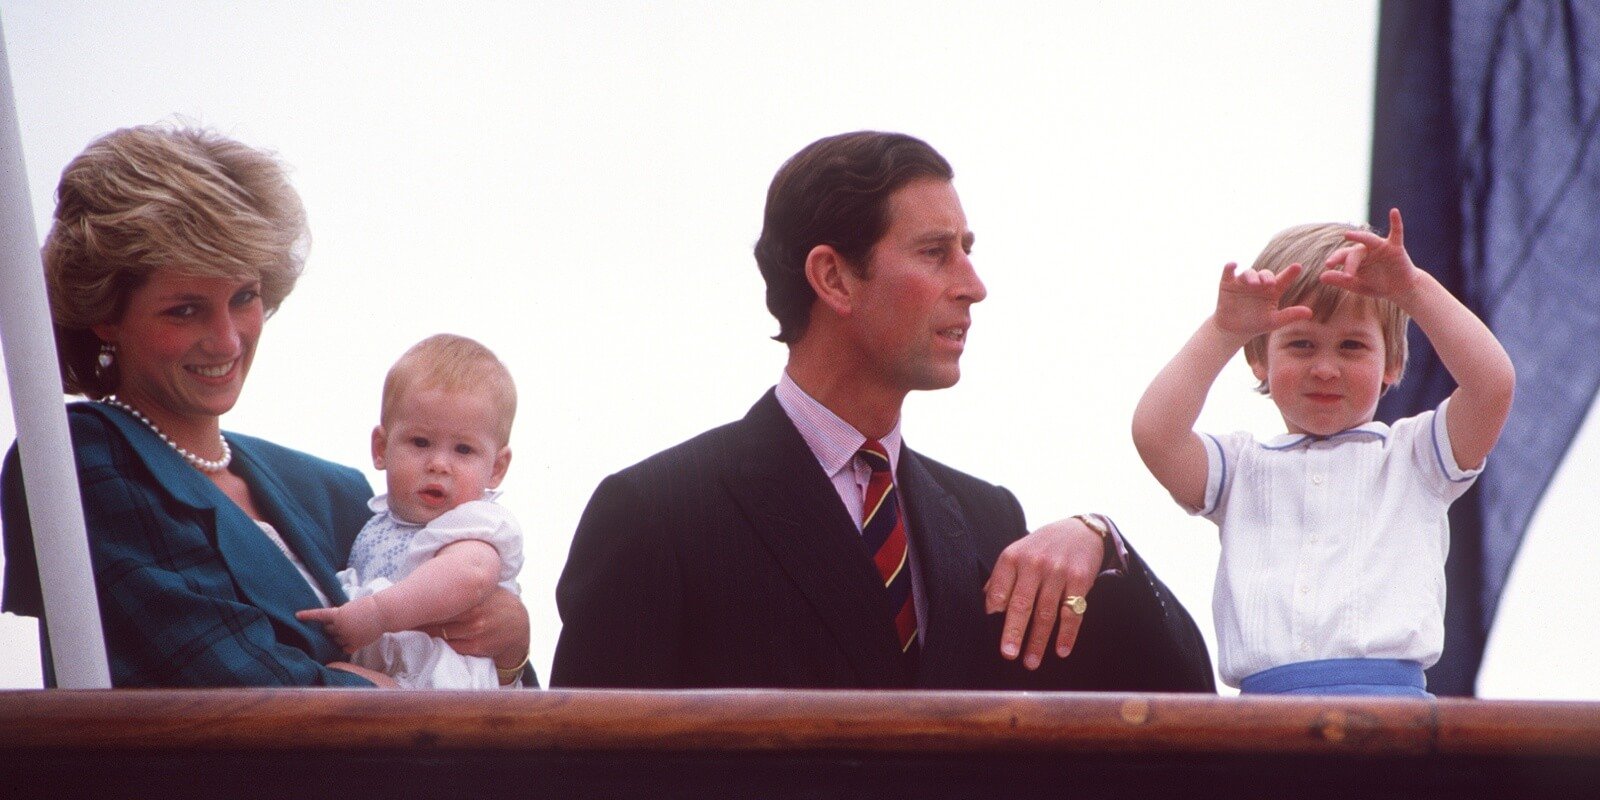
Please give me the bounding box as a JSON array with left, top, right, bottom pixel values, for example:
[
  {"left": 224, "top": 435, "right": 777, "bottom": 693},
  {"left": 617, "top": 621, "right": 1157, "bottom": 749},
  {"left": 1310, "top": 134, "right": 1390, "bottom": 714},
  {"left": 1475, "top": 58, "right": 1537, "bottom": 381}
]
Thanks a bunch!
[{"left": 339, "top": 491, "right": 522, "bottom": 690}]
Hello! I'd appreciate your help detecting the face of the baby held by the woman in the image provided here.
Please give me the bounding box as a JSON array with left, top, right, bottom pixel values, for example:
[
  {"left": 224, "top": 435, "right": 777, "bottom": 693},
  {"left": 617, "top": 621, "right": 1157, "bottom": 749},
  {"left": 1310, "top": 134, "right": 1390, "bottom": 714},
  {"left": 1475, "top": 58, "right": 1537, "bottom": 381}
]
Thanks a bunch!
[{"left": 373, "top": 387, "right": 510, "bottom": 525}]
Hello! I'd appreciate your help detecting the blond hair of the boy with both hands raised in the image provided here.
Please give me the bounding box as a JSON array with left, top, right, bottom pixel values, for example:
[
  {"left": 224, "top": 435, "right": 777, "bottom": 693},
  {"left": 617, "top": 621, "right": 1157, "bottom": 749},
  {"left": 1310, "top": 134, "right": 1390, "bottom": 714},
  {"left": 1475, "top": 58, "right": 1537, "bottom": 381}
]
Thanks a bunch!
[{"left": 1245, "top": 222, "right": 1411, "bottom": 394}]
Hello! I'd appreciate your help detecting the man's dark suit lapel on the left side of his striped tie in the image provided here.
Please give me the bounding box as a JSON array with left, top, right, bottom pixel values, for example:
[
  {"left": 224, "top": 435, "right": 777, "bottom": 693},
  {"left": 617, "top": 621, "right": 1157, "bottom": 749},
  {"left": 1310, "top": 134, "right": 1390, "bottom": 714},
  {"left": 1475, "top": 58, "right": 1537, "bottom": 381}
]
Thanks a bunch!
[{"left": 723, "top": 392, "right": 907, "bottom": 686}]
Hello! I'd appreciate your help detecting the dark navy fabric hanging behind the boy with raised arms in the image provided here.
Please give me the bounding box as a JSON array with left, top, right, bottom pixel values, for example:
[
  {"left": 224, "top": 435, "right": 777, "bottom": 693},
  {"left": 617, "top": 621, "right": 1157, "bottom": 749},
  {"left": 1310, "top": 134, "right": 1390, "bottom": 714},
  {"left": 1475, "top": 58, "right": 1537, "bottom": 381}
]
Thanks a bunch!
[{"left": 1370, "top": 0, "right": 1600, "bottom": 694}]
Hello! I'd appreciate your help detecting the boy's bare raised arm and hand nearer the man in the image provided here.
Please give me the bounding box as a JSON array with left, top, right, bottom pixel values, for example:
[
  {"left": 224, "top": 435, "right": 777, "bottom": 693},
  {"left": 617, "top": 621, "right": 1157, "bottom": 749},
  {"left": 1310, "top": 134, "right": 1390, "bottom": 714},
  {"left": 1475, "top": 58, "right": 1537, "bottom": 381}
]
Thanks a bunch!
[{"left": 1133, "top": 264, "right": 1310, "bottom": 509}]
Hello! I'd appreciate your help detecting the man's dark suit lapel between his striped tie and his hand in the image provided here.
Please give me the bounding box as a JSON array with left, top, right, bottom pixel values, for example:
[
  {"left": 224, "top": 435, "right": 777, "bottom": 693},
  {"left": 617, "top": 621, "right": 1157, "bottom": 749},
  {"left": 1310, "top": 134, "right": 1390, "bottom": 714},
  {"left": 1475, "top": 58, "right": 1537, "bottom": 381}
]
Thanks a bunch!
[{"left": 894, "top": 446, "right": 1000, "bottom": 688}]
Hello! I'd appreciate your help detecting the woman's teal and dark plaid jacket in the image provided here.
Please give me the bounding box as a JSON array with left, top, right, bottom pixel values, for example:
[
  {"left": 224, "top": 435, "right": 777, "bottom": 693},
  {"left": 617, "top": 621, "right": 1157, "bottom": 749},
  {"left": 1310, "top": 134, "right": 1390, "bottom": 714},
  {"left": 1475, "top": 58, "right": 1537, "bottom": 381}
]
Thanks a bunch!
[{"left": 0, "top": 403, "right": 371, "bottom": 686}]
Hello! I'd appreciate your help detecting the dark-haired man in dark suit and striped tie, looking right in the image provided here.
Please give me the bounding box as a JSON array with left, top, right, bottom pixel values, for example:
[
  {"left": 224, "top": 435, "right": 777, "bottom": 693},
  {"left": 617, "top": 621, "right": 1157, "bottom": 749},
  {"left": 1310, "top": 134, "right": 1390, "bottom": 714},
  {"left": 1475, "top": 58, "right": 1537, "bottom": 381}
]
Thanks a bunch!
[{"left": 552, "top": 131, "right": 1214, "bottom": 691}]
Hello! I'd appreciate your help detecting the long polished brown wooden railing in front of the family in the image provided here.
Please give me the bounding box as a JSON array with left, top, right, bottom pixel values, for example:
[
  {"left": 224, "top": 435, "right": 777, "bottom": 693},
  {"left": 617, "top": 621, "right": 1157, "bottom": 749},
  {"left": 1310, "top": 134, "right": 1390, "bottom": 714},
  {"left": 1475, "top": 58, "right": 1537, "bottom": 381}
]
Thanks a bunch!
[{"left": 0, "top": 690, "right": 1600, "bottom": 800}]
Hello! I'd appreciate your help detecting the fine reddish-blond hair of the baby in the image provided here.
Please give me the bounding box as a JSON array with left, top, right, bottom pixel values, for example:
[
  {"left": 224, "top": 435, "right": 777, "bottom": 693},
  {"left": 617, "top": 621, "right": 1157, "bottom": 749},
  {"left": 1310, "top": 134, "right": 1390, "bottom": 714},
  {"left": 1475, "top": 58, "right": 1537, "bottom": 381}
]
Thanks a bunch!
[{"left": 379, "top": 333, "right": 517, "bottom": 446}]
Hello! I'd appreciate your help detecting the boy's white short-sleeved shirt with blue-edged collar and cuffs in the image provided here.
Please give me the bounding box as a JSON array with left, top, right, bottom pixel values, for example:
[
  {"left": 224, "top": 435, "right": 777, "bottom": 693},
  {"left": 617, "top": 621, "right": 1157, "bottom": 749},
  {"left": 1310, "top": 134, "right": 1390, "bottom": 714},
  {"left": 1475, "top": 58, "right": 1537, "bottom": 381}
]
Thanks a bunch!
[{"left": 1189, "top": 400, "right": 1482, "bottom": 686}]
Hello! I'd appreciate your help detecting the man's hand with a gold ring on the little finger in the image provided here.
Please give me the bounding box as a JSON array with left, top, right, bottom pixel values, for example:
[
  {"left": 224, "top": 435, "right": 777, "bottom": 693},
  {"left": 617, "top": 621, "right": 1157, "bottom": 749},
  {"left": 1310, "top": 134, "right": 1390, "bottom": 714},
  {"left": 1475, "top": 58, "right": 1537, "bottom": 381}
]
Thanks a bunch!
[{"left": 984, "top": 518, "right": 1106, "bottom": 669}]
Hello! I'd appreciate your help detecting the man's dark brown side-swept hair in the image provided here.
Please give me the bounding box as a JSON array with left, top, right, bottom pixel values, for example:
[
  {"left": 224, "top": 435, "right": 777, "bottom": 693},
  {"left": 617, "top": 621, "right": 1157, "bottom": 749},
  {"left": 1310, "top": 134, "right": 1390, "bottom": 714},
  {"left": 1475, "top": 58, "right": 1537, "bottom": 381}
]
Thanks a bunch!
[{"left": 755, "top": 131, "right": 955, "bottom": 344}]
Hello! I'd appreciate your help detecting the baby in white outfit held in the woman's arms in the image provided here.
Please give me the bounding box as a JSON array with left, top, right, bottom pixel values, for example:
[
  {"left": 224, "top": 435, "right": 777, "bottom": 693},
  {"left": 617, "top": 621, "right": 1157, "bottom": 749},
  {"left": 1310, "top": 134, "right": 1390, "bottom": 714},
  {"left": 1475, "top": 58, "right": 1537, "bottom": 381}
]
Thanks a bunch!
[{"left": 296, "top": 334, "right": 522, "bottom": 688}]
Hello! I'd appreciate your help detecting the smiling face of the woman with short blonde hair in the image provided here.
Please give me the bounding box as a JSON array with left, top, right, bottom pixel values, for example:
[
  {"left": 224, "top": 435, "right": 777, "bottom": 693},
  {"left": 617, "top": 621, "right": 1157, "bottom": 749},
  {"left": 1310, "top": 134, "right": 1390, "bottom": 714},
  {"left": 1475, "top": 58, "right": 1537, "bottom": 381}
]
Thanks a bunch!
[{"left": 94, "top": 269, "right": 266, "bottom": 426}]
